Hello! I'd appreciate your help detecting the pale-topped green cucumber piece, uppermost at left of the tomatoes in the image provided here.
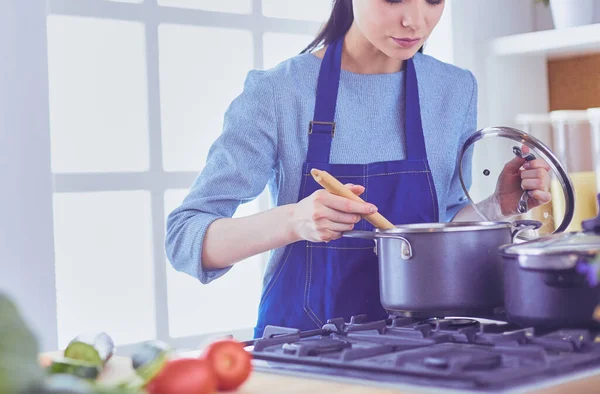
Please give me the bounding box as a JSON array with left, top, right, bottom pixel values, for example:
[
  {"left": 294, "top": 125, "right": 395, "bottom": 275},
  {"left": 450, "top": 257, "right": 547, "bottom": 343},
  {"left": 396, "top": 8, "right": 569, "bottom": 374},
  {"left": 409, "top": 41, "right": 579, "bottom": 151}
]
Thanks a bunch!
[{"left": 64, "top": 332, "right": 115, "bottom": 366}]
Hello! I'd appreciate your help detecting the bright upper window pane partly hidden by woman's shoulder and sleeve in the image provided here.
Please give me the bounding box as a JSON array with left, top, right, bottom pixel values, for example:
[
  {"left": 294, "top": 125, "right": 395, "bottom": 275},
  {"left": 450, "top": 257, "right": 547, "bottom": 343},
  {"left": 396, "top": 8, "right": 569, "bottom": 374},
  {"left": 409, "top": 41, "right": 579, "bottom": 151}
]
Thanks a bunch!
[{"left": 159, "top": 25, "right": 253, "bottom": 171}]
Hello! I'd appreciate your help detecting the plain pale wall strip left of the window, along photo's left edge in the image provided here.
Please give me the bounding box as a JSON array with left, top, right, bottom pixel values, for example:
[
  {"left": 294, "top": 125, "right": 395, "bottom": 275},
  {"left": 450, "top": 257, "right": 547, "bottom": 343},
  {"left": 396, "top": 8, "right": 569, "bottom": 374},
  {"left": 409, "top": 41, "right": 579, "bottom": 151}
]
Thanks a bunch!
[{"left": 0, "top": 0, "right": 57, "bottom": 350}]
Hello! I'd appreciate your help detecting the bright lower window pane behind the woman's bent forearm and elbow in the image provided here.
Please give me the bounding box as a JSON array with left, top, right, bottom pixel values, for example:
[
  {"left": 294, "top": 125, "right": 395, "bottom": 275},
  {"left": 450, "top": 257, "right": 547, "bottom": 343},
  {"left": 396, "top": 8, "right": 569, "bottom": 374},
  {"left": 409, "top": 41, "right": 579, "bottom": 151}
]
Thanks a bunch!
[{"left": 165, "top": 190, "right": 266, "bottom": 337}]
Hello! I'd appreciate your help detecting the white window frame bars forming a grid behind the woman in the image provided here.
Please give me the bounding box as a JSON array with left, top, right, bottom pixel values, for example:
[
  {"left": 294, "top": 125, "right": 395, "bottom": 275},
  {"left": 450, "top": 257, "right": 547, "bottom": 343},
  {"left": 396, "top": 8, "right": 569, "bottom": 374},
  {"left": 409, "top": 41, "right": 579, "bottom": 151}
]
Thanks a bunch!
[{"left": 47, "top": 0, "right": 320, "bottom": 353}]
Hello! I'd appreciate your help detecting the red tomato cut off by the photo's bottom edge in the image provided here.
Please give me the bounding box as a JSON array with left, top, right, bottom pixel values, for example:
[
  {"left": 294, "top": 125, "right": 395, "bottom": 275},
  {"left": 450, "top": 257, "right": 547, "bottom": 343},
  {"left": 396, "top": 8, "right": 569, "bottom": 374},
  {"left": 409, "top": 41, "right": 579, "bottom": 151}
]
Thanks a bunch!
[{"left": 146, "top": 358, "right": 217, "bottom": 394}]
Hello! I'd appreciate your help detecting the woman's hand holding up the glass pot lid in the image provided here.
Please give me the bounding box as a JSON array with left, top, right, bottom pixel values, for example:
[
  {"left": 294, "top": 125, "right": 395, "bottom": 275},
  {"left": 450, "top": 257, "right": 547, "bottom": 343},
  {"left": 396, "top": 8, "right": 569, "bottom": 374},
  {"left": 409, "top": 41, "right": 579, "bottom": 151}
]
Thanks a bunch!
[{"left": 496, "top": 146, "right": 552, "bottom": 217}]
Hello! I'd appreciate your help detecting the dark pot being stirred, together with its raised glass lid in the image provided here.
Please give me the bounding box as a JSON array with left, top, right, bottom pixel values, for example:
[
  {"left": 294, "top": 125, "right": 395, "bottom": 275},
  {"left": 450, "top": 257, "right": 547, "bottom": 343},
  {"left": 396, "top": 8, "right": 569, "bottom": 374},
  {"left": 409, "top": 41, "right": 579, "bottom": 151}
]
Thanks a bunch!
[{"left": 328, "top": 127, "right": 574, "bottom": 317}]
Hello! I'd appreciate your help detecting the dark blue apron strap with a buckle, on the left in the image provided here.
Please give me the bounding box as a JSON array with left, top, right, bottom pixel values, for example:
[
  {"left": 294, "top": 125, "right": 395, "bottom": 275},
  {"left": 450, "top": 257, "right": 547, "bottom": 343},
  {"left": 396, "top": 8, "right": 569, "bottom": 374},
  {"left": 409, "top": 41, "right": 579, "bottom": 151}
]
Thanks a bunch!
[{"left": 306, "top": 39, "right": 343, "bottom": 163}]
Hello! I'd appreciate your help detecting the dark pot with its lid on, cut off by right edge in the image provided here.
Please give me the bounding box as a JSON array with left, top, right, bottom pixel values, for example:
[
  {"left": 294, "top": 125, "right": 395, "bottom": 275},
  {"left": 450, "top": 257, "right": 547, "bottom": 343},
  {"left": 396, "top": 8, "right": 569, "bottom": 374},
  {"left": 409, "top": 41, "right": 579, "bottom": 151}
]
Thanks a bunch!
[{"left": 500, "top": 195, "right": 600, "bottom": 328}]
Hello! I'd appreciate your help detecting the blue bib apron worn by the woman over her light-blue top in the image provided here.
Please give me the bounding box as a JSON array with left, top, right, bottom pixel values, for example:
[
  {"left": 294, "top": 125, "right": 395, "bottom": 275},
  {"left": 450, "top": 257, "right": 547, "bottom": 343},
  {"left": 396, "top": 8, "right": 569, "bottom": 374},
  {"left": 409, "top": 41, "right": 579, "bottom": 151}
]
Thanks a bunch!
[{"left": 254, "top": 39, "right": 439, "bottom": 338}]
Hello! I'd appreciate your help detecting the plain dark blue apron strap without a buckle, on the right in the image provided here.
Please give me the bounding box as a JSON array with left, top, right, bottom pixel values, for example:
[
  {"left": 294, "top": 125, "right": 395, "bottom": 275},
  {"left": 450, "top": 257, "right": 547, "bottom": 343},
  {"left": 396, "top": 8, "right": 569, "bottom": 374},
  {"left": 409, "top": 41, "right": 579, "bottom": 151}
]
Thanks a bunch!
[{"left": 404, "top": 58, "right": 427, "bottom": 160}]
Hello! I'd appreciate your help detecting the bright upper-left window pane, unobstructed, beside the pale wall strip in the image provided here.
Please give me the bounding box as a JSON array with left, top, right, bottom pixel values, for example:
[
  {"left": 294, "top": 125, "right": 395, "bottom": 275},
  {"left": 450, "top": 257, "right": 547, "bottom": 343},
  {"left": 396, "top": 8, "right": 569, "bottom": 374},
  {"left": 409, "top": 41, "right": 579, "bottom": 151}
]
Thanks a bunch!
[{"left": 48, "top": 15, "right": 149, "bottom": 172}]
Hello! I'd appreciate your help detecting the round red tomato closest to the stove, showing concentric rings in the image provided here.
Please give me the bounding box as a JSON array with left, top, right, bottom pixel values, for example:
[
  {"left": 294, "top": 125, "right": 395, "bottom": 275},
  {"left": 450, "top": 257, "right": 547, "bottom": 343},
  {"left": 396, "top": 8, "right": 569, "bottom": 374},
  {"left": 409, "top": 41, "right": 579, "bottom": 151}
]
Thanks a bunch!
[{"left": 203, "top": 339, "right": 252, "bottom": 391}]
